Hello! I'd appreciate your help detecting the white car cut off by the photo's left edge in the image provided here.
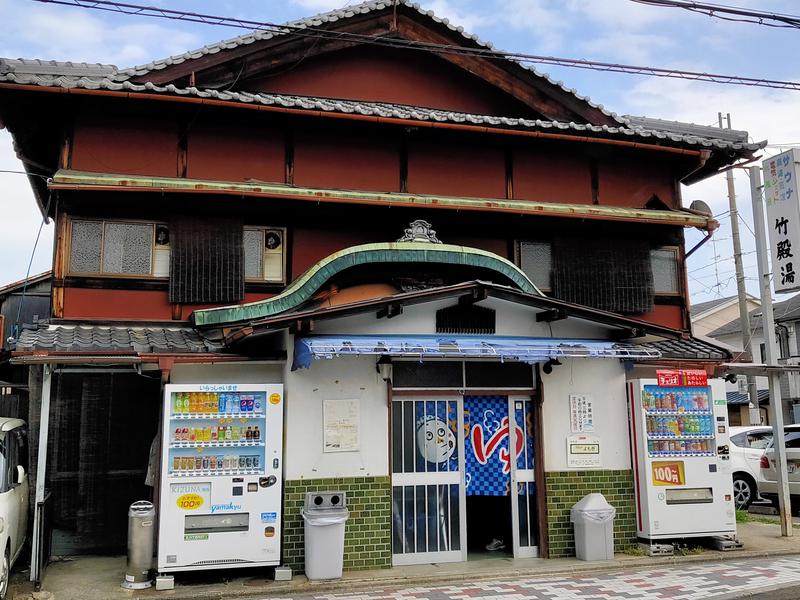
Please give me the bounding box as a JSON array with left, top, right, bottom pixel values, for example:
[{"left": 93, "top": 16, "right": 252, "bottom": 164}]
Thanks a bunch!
[{"left": 0, "top": 417, "right": 28, "bottom": 599}]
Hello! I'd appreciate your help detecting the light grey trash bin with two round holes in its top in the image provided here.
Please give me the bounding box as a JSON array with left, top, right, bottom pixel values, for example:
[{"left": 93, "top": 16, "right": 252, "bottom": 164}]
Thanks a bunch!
[{"left": 300, "top": 492, "right": 350, "bottom": 580}]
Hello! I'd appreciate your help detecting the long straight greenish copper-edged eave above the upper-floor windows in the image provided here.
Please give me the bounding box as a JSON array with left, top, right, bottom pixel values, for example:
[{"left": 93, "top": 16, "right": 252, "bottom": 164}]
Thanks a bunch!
[{"left": 49, "top": 169, "right": 719, "bottom": 231}]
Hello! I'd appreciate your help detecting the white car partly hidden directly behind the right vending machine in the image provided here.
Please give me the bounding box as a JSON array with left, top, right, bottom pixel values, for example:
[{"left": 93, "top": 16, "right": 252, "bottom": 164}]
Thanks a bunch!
[{"left": 730, "top": 426, "right": 772, "bottom": 510}]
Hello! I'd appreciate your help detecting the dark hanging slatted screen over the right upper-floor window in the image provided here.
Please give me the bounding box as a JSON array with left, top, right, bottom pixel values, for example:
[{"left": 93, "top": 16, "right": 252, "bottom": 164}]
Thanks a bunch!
[{"left": 553, "top": 238, "right": 655, "bottom": 314}]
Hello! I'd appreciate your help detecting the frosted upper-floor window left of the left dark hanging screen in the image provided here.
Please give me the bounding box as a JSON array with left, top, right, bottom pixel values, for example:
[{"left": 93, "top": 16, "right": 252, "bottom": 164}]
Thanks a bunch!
[{"left": 69, "top": 219, "right": 169, "bottom": 277}]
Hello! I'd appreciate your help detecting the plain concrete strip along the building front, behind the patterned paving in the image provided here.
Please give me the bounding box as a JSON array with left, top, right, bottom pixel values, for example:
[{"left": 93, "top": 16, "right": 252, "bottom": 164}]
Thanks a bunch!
[{"left": 9, "top": 522, "right": 800, "bottom": 600}]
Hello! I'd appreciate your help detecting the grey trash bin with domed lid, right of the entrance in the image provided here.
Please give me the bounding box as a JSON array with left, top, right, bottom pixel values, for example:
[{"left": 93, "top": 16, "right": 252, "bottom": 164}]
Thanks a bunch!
[{"left": 570, "top": 494, "right": 617, "bottom": 560}]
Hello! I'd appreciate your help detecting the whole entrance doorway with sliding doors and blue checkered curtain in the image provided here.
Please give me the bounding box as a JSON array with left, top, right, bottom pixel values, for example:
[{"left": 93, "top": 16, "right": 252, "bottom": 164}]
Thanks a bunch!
[{"left": 392, "top": 392, "right": 538, "bottom": 565}]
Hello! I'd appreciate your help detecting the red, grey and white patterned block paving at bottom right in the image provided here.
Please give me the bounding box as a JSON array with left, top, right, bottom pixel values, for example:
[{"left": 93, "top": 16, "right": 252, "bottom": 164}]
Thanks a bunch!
[{"left": 292, "top": 557, "right": 798, "bottom": 600}]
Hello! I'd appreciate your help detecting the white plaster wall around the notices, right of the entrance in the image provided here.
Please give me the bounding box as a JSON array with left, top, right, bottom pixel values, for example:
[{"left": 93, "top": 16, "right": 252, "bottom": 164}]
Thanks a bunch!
[{"left": 542, "top": 359, "right": 631, "bottom": 471}]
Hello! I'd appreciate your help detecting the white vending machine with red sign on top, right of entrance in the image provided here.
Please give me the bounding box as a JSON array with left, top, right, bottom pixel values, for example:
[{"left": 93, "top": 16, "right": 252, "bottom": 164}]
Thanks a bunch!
[{"left": 629, "top": 371, "right": 736, "bottom": 541}]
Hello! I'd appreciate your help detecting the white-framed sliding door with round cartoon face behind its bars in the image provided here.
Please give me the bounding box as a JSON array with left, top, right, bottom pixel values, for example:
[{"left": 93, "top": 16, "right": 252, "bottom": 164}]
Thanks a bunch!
[{"left": 392, "top": 395, "right": 467, "bottom": 565}]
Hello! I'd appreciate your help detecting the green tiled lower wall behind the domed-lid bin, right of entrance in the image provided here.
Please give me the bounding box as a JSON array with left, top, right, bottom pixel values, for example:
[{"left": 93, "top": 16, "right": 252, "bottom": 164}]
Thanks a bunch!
[{"left": 545, "top": 470, "right": 636, "bottom": 558}]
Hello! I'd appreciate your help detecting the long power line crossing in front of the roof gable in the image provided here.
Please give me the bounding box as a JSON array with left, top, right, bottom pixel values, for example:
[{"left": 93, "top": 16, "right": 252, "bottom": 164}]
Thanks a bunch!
[{"left": 33, "top": 0, "right": 800, "bottom": 91}]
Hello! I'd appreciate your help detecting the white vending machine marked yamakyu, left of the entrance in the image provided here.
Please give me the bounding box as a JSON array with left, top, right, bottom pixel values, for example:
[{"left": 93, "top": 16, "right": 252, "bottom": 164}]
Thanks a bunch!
[{"left": 158, "top": 384, "right": 283, "bottom": 572}]
